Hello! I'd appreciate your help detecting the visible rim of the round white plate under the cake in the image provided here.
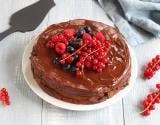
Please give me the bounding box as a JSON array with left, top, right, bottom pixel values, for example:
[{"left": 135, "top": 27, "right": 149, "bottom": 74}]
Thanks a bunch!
[{"left": 22, "top": 36, "right": 137, "bottom": 111}]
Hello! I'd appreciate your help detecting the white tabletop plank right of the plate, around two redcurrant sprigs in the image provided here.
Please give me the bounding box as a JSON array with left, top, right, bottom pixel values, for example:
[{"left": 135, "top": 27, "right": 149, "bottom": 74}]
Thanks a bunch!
[{"left": 124, "top": 39, "right": 160, "bottom": 125}]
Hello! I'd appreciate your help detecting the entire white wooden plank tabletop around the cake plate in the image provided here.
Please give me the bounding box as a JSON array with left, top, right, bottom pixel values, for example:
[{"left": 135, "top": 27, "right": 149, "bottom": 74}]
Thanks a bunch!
[{"left": 0, "top": 0, "right": 160, "bottom": 125}]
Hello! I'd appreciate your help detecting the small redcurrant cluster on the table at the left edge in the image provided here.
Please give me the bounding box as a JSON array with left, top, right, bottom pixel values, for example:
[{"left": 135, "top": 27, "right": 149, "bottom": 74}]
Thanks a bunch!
[{"left": 0, "top": 88, "right": 10, "bottom": 105}]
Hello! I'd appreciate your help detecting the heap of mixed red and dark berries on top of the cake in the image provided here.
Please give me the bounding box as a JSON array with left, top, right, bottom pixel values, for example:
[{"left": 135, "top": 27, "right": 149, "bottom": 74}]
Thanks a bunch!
[{"left": 46, "top": 26, "right": 110, "bottom": 76}]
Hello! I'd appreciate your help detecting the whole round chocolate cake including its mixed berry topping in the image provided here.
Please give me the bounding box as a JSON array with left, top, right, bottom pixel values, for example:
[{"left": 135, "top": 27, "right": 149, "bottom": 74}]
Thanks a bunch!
[{"left": 30, "top": 19, "right": 131, "bottom": 104}]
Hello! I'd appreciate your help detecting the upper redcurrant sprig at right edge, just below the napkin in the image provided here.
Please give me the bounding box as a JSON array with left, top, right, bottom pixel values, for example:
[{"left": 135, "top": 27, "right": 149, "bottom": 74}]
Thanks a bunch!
[{"left": 144, "top": 55, "right": 160, "bottom": 79}]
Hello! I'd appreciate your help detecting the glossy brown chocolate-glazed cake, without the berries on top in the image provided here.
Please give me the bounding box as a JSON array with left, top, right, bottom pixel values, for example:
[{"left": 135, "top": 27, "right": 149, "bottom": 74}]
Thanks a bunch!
[{"left": 30, "top": 19, "right": 131, "bottom": 104}]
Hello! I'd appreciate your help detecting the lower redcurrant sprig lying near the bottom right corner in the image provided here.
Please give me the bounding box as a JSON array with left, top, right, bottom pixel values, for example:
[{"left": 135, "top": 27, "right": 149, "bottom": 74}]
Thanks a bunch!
[{"left": 141, "top": 84, "right": 160, "bottom": 116}]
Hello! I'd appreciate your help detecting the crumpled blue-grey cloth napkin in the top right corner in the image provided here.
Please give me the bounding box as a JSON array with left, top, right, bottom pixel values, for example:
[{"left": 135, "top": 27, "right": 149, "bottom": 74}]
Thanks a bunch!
[{"left": 98, "top": 0, "right": 160, "bottom": 46}]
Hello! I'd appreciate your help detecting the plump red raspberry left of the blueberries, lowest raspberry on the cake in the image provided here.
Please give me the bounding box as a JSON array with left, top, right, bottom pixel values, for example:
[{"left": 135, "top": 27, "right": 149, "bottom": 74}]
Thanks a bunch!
[{"left": 55, "top": 43, "right": 66, "bottom": 54}]
